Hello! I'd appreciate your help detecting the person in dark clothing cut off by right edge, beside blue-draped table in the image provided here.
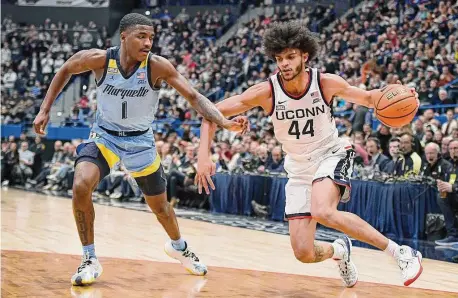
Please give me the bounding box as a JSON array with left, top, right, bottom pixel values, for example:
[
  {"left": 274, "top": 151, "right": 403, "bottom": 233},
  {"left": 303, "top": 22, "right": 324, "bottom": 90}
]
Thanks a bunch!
[{"left": 436, "top": 139, "right": 458, "bottom": 246}]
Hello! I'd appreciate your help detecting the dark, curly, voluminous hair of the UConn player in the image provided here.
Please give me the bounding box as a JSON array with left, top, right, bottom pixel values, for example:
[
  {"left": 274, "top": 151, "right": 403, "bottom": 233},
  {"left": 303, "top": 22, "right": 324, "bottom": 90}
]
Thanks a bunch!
[{"left": 263, "top": 20, "right": 319, "bottom": 61}]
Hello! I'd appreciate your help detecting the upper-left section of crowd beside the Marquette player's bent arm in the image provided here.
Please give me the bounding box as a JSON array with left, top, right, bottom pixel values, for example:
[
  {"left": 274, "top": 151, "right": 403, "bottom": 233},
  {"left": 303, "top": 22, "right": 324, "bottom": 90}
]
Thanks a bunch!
[{"left": 1, "top": 17, "right": 110, "bottom": 124}]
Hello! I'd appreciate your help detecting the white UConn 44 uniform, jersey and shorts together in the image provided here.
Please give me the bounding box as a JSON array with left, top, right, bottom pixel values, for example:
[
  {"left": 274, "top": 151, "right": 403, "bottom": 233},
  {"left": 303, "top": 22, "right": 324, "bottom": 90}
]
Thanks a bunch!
[{"left": 269, "top": 68, "right": 354, "bottom": 219}]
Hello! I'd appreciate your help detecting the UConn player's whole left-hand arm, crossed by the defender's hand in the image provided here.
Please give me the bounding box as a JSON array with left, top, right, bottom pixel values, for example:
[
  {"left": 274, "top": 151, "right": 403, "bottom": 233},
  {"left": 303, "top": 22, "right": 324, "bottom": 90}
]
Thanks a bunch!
[{"left": 194, "top": 82, "right": 272, "bottom": 194}]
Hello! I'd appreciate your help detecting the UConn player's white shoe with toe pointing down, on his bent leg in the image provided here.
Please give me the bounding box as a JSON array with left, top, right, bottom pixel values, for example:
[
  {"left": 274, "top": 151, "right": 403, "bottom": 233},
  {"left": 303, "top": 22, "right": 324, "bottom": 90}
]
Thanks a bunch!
[{"left": 334, "top": 236, "right": 358, "bottom": 288}]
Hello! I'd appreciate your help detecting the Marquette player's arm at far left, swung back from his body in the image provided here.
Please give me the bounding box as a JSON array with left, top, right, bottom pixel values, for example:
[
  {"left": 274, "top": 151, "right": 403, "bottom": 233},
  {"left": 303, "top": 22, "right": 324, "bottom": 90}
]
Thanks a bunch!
[{"left": 33, "top": 49, "right": 106, "bottom": 135}]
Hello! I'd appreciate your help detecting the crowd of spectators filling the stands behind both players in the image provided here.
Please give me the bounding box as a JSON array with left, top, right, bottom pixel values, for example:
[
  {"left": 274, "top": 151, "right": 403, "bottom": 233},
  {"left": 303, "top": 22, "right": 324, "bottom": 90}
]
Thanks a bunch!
[{"left": 1, "top": 1, "right": 458, "bottom": 212}]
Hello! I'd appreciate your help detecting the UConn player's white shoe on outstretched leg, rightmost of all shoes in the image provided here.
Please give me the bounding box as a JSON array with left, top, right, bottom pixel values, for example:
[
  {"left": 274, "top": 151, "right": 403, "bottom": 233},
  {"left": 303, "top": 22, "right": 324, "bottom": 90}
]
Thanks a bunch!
[{"left": 394, "top": 245, "right": 423, "bottom": 287}]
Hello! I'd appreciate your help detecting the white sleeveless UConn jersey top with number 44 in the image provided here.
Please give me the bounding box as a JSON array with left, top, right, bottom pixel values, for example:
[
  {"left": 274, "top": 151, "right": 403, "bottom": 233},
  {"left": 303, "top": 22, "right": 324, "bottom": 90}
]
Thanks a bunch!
[{"left": 270, "top": 68, "right": 339, "bottom": 166}]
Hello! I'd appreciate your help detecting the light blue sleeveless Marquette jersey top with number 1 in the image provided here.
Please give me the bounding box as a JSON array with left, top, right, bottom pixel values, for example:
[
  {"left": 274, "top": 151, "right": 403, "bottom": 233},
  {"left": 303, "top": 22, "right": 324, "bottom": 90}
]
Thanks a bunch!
[{"left": 94, "top": 47, "right": 159, "bottom": 131}]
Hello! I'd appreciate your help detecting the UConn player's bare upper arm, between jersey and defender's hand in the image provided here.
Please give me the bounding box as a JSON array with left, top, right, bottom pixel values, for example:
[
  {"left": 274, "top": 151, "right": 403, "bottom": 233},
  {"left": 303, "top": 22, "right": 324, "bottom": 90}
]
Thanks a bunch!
[{"left": 216, "top": 82, "right": 272, "bottom": 117}]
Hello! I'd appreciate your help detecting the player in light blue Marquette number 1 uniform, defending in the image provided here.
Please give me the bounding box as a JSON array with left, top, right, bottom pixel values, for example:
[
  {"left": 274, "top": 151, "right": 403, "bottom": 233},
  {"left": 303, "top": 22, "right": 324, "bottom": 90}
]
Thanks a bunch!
[{"left": 34, "top": 13, "right": 244, "bottom": 285}]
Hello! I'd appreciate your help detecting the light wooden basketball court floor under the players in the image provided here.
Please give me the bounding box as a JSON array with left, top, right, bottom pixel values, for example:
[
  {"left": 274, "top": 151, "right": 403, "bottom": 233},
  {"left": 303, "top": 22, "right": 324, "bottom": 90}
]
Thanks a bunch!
[{"left": 1, "top": 189, "right": 458, "bottom": 298}]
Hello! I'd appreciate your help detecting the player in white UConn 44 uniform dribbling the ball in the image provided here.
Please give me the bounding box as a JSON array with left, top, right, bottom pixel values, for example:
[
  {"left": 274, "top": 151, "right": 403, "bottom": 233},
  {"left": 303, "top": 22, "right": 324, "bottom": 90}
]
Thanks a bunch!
[{"left": 196, "top": 21, "right": 422, "bottom": 287}]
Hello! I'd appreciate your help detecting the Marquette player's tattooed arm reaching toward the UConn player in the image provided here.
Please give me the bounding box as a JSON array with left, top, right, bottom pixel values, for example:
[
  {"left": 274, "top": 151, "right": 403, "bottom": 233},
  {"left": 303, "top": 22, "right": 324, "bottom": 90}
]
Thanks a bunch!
[{"left": 150, "top": 56, "right": 244, "bottom": 131}]
